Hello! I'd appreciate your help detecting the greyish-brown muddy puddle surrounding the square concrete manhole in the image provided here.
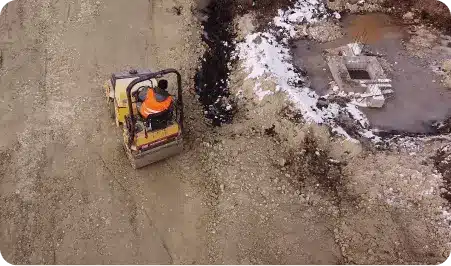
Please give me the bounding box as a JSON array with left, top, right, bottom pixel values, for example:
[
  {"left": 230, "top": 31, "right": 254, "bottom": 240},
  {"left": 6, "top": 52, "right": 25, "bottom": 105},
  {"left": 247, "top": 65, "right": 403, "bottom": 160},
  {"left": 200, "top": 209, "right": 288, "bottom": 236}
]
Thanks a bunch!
[{"left": 293, "top": 13, "right": 451, "bottom": 133}]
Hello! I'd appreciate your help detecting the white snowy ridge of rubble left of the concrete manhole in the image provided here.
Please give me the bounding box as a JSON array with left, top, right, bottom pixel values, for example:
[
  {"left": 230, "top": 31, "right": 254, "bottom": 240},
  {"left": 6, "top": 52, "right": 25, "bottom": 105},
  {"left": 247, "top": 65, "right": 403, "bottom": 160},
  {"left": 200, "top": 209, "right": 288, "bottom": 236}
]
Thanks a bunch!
[{"left": 234, "top": 0, "right": 380, "bottom": 142}]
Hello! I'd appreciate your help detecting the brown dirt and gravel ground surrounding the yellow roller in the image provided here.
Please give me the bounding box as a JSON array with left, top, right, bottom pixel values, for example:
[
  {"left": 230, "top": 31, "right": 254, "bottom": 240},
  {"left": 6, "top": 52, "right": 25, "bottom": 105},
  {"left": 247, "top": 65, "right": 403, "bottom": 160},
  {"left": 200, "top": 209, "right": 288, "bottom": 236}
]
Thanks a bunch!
[{"left": 0, "top": 0, "right": 451, "bottom": 264}]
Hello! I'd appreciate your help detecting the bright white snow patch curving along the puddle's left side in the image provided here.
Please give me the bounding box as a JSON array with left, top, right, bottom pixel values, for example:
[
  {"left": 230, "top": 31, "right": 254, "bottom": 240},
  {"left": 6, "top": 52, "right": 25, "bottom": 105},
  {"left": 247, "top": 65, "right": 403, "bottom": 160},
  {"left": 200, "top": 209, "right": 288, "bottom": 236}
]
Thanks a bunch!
[{"left": 236, "top": 0, "right": 380, "bottom": 142}]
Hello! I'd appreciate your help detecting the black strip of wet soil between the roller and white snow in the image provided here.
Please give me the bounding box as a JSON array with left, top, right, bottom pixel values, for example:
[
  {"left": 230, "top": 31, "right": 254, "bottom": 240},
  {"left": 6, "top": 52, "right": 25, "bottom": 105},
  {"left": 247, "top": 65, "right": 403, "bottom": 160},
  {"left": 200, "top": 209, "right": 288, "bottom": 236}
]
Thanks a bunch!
[{"left": 194, "top": 0, "right": 236, "bottom": 126}]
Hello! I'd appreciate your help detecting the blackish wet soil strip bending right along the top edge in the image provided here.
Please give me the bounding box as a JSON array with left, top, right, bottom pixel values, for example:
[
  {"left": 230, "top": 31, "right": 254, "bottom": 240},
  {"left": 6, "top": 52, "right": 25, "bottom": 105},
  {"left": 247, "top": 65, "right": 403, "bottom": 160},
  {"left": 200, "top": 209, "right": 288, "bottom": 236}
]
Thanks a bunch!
[{"left": 194, "top": 0, "right": 295, "bottom": 126}]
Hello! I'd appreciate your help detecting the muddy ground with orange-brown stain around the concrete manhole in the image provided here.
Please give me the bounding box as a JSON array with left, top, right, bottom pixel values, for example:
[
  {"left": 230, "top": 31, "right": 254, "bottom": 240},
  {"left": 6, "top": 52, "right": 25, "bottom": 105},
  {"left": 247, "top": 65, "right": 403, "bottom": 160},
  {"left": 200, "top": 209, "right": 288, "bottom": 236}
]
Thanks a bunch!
[{"left": 293, "top": 13, "right": 451, "bottom": 133}]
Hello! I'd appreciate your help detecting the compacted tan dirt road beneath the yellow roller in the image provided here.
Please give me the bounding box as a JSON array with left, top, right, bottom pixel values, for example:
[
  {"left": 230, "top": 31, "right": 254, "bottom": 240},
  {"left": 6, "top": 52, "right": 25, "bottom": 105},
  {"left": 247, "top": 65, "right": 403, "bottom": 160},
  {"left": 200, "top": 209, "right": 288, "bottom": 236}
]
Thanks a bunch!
[{"left": 0, "top": 0, "right": 212, "bottom": 264}]
